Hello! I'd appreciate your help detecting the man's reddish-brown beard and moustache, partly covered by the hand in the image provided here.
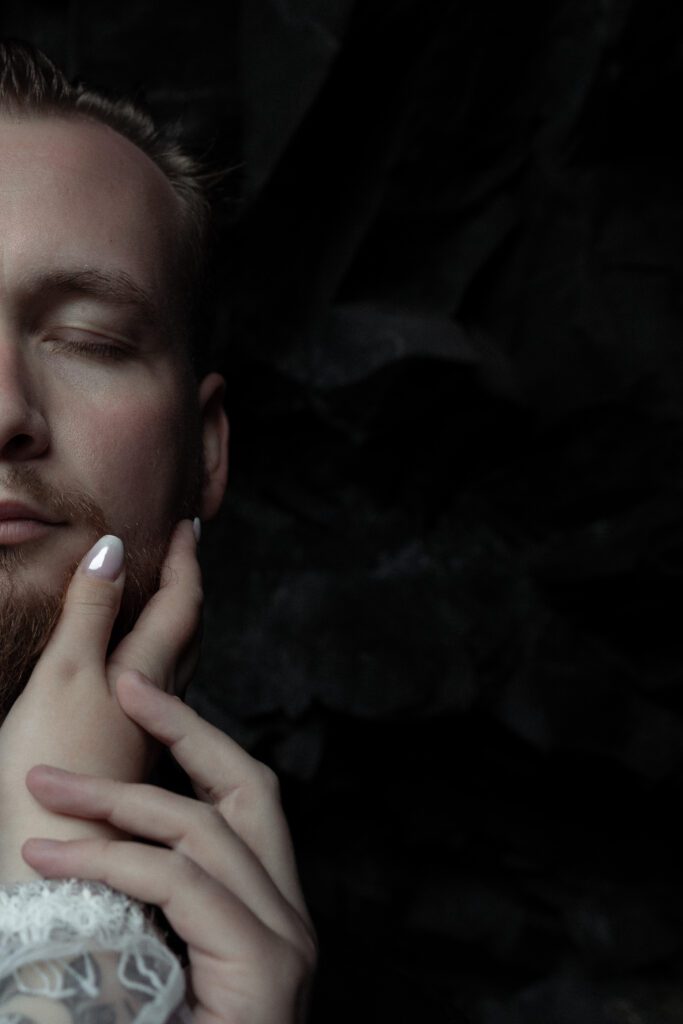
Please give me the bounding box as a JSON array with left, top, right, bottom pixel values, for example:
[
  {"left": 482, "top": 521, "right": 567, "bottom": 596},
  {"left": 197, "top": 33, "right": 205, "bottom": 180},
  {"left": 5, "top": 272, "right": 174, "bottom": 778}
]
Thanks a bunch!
[{"left": 0, "top": 459, "right": 203, "bottom": 724}]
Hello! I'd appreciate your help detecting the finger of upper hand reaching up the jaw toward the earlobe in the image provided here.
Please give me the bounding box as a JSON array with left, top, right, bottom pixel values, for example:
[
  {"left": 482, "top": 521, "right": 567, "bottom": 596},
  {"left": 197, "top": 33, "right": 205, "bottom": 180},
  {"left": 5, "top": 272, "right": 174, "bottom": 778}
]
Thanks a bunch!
[{"left": 109, "top": 519, "right": 203, "bottom": 689}]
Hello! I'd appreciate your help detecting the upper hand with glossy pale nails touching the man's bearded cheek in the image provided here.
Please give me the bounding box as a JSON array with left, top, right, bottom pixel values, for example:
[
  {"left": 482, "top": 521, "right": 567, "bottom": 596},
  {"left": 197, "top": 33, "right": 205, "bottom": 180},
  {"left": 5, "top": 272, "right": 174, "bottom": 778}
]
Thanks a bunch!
[{"left": 0, "top": 520, "right": 202, "bottom": 883}]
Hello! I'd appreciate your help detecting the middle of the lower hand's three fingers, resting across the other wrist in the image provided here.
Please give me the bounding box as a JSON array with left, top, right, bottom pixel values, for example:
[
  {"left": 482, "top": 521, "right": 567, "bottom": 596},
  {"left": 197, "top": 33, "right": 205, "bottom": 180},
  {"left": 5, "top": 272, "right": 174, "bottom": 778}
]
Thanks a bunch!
[{"left": 27, "top": 765, "right": 299, "bottom": 941}]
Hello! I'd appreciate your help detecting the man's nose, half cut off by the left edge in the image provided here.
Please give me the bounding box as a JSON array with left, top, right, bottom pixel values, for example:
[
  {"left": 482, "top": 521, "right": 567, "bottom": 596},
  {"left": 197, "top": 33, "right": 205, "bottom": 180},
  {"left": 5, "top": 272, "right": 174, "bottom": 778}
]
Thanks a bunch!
[{"left": 0, "top": 339, "right": 49, "bottom": 463}]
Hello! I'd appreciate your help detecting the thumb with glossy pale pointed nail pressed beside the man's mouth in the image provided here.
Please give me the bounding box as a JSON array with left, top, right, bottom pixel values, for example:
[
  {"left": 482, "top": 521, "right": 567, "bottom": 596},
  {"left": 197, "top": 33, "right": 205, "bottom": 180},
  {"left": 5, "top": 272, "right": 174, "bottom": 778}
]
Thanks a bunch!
[{"left": 41, "top": 535, "right": 125, "bottom": 668}]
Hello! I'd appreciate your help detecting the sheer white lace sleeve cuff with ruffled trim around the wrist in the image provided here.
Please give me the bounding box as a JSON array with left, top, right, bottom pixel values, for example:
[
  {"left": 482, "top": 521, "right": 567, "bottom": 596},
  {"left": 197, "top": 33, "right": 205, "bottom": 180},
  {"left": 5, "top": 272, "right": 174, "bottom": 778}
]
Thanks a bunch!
[{"left": 0, "top": 879, "right": 193, "bottom": 1024}]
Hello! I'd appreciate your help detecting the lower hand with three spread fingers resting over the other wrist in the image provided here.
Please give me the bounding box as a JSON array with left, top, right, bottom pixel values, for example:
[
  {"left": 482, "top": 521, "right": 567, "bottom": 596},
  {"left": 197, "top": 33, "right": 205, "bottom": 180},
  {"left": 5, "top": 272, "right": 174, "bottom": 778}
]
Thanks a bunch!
[{"left": 22, "top": 672, "right": 315, "bottom": 1024}]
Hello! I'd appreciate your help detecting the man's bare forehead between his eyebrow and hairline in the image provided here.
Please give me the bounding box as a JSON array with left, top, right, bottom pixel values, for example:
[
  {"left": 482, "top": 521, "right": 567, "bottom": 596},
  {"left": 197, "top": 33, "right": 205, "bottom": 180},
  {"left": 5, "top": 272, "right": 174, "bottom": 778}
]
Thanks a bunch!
[{"left": 0, "top": 114, "right": 179, "bottom": 307}]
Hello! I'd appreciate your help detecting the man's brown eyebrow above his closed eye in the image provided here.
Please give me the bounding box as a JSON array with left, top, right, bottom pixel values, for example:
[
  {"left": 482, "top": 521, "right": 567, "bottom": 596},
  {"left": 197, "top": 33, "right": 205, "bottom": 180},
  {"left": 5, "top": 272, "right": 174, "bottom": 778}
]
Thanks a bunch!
[{"left": 19, "top": 267, "right": 170, "bottom": 330}]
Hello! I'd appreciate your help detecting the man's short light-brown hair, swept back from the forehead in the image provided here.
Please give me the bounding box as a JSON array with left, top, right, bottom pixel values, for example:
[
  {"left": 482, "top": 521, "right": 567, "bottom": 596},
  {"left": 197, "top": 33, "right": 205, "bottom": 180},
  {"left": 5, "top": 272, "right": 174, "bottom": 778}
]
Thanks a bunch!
[{"left": 0, "top": 39, "right": 220, "bottom": 372}]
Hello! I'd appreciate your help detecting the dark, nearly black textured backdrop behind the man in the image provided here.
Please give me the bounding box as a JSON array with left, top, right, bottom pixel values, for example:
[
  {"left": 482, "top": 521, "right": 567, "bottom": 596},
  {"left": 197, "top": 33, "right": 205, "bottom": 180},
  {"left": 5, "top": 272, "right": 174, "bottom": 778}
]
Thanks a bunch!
[{"left": 1, "top": 0, "right": 683, "bottom": 1024}]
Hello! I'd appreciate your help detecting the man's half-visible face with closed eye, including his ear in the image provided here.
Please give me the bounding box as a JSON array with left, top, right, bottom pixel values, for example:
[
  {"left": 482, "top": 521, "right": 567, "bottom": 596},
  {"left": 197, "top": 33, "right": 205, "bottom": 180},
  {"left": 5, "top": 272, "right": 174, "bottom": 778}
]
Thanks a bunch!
[{"left": 0, "top": 113, "right": 225, "bottom": 704}]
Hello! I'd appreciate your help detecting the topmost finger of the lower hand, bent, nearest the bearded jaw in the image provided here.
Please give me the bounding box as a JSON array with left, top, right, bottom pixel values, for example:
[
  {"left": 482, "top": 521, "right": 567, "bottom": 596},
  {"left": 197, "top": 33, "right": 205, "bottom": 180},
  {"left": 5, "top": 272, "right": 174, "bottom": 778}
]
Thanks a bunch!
[{"left": 117, "top": 673, "right": 310, "bottom": 924}]
